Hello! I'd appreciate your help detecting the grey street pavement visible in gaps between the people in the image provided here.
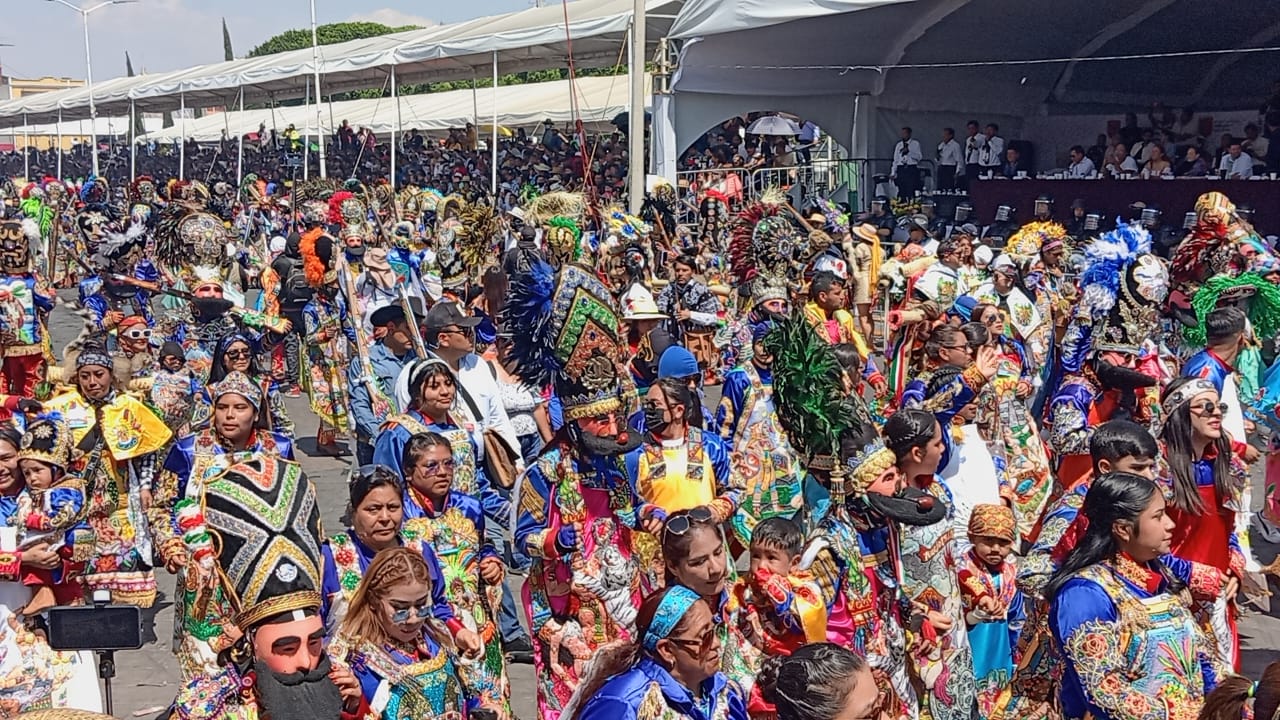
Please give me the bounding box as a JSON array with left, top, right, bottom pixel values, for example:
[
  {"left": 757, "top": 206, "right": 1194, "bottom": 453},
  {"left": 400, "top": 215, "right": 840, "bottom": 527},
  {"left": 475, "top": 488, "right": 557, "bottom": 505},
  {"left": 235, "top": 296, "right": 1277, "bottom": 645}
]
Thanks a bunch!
[{"left": 37, "top": 292, "right": 1280, "bottom": 720}]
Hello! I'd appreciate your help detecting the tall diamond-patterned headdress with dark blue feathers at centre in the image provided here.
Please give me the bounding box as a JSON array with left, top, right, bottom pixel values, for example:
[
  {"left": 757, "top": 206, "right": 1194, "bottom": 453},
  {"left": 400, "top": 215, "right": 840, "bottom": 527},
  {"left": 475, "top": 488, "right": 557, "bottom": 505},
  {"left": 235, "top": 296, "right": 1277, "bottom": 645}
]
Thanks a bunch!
[{"left": 503, "top": 259, "right": 627, "bottom": 421}]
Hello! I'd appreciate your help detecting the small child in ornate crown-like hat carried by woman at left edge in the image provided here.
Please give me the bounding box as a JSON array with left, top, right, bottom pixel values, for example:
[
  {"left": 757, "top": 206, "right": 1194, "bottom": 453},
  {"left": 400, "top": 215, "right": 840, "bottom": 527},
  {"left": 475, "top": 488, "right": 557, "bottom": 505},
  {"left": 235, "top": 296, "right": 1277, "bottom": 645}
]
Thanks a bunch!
[{"left": 17, "top": 413, "right": 93, "bottom": 615}]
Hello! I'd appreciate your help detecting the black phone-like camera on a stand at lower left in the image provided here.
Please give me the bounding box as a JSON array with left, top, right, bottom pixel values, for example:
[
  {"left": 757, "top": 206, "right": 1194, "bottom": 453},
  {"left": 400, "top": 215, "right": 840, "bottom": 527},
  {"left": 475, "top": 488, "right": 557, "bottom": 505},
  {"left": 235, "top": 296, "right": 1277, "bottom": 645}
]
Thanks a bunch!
[{"left": 46, "top": 591, "right": 142, "bottom": 715}]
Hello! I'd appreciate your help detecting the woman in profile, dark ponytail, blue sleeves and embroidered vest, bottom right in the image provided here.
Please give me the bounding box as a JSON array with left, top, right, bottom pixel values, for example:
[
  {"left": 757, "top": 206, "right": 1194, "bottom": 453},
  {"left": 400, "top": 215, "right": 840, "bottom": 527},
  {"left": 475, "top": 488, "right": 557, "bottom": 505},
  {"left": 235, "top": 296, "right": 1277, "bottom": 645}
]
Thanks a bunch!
[{"left": 1044, "top": 473, "right": 1226, "bottom": 720}]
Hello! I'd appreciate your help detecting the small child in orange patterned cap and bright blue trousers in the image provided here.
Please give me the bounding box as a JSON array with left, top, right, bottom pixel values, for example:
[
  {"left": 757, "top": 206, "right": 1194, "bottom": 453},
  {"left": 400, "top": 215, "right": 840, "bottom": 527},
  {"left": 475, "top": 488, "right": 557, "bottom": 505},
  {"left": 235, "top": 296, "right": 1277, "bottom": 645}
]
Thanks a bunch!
[{"left": 959, "top": 505, "right": 1027, "bottom": 717}]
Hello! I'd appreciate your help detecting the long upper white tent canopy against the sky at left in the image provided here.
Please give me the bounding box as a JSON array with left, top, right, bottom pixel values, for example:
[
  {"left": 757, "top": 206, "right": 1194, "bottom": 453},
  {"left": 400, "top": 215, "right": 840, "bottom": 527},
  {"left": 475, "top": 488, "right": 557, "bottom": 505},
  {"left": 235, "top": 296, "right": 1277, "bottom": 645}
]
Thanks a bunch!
[{"left": 0, "top": 0, "right": 681, "bottom": 124}]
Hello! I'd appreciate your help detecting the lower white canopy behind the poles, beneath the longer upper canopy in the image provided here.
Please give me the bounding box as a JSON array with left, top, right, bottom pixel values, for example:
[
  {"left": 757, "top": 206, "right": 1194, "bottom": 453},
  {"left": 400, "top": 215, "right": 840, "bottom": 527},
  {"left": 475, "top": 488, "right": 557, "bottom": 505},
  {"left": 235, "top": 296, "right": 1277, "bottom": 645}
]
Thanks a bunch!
[{"left": 142, "top": 76, "right": 650, "bottom": 141}]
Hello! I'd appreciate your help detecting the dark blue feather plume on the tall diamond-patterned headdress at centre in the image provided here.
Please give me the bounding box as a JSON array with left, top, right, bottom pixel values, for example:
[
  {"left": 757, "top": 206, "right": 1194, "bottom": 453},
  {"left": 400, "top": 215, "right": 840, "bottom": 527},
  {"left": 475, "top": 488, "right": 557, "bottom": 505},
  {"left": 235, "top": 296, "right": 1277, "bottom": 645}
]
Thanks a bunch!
[{"left": 502, "top": 259, "right": 563, "bottom": 388}]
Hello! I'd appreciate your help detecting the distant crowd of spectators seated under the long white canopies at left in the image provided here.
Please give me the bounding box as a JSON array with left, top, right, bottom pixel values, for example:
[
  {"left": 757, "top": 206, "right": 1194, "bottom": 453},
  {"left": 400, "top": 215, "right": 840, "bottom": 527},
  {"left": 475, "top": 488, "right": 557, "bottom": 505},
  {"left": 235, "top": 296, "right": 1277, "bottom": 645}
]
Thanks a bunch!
[{"left": 0, "top": 120, "right": 627, "bottom": 208}]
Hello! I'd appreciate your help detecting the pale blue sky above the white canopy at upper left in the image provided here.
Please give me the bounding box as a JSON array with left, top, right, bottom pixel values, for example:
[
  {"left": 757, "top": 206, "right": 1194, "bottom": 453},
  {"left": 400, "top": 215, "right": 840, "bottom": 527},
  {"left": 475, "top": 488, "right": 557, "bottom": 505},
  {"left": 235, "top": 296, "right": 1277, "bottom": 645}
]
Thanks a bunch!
[{"left": 0, "top": 0, "right": 534, "bottom": 81}]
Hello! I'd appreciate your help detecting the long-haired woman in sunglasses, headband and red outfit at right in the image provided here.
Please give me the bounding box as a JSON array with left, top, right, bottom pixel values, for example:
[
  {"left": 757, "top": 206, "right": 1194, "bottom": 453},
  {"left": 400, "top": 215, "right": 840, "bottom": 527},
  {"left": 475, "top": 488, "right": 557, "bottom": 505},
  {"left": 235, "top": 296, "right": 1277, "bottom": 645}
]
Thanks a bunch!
[{"left": 1160, "top": 378, "right": 1249, "bottom": 667}]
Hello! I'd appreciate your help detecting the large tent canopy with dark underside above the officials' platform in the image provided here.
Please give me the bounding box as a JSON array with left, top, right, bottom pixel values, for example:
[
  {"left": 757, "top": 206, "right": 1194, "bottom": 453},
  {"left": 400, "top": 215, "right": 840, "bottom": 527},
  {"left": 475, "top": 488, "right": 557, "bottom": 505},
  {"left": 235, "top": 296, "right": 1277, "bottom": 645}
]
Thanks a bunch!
[{"left": 654, "top": 0, "right": 1280, "bottom": 170}]
